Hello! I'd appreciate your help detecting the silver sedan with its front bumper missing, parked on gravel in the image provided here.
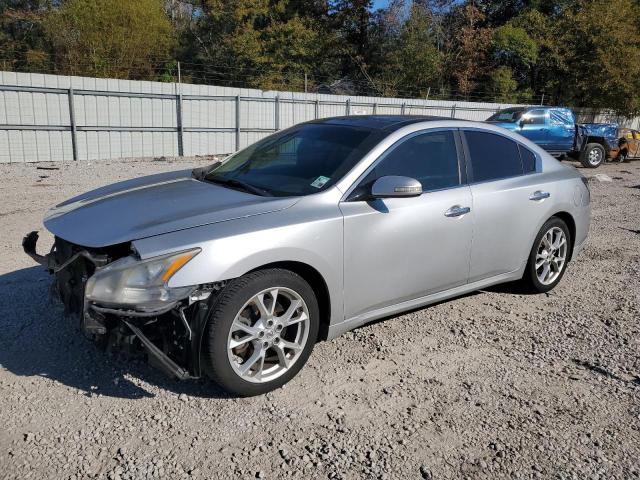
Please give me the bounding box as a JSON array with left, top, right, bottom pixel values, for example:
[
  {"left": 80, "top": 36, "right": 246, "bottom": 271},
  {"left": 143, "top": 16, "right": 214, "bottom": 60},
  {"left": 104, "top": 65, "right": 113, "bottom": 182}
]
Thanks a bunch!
[{"left": 23, "top": 116, "right": 590, "bottom": 395}]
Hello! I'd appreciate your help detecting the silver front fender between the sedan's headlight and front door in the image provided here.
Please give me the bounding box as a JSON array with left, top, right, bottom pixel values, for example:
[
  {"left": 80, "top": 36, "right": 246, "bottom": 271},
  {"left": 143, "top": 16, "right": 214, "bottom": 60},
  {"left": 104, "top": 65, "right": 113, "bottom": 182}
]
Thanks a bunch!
[{"left": 134, "top": 201, "right": 344, "bottom": 323}]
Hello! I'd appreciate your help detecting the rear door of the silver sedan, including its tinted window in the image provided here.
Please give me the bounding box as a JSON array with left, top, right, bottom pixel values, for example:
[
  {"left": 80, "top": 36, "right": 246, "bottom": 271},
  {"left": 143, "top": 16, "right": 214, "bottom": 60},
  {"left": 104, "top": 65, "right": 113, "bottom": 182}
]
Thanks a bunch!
[{"left": 463, "top": 129, "right": 550, "bottom": 282}]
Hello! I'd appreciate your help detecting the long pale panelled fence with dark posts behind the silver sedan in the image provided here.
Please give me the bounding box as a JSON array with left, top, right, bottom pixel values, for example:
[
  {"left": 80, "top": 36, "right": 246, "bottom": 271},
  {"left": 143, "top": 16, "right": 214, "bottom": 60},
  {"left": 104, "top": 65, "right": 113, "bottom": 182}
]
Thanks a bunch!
[{"left": 0, "top": 72, "right": 640, "bottom": 163}]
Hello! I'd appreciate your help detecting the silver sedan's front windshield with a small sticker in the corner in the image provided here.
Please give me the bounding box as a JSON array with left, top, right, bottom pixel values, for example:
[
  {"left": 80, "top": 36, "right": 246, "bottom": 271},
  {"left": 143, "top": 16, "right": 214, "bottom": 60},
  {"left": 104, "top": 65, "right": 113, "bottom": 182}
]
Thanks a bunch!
[{"left": 204, "top": 123, "right": 382, "bottom": 197}]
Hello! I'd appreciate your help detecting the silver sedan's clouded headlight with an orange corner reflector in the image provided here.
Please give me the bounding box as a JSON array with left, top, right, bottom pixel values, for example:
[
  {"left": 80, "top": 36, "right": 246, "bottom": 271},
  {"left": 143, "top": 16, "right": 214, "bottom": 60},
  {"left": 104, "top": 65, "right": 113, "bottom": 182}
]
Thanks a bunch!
[{"left": 85, "top": 248, "right": 200, "bottom": 312}]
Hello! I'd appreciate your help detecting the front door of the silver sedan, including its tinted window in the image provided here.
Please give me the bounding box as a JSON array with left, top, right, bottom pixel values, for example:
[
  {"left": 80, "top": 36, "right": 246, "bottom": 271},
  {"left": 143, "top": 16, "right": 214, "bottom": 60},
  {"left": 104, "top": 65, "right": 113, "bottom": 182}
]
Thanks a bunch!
[{"left": 340, "top": 130, "right": 473, "bottom": 318}]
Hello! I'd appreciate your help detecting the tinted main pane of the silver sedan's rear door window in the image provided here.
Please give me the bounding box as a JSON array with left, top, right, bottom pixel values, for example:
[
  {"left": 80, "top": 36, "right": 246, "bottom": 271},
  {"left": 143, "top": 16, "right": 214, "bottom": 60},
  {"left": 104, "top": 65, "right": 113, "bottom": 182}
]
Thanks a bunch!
[{"left": 464, "top": 130, "right": 524, "bottom": 182}]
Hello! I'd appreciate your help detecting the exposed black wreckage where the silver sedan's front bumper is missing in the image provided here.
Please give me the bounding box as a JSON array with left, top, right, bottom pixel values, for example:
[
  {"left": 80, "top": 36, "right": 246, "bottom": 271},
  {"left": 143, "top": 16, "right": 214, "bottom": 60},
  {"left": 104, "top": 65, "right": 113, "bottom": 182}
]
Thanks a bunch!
[{"left": 22, "top": 232, "right": 215, "bottom": 380}]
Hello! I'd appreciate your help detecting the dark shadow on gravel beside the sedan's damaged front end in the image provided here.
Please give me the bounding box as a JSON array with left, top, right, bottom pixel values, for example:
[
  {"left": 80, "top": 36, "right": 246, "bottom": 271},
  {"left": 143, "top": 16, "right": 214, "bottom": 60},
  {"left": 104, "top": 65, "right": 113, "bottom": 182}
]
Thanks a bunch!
[{"left": 0, "top": 266, "right": 230, "bottom": 399}]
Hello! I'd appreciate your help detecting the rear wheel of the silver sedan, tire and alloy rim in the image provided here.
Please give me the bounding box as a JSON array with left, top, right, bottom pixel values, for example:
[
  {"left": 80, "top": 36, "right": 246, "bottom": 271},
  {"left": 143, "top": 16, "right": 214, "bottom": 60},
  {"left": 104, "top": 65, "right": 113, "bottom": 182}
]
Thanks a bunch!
[{"left": 522, "top": 217, "right": 571, "bottom": 293}]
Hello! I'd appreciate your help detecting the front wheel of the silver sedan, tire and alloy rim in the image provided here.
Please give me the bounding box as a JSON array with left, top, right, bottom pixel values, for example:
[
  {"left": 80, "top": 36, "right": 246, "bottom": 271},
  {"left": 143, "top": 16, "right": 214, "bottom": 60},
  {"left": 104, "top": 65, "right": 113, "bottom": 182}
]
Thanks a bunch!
[{"left": 203, "top": 269, "right": 320, "bottom": 397}]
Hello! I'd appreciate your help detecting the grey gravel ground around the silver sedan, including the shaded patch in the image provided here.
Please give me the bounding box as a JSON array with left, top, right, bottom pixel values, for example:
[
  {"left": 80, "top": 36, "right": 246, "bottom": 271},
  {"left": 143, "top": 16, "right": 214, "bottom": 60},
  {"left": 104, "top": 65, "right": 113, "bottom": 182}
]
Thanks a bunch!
[{"left": 0, "top": 158, "right": 640, "bottom": 479}]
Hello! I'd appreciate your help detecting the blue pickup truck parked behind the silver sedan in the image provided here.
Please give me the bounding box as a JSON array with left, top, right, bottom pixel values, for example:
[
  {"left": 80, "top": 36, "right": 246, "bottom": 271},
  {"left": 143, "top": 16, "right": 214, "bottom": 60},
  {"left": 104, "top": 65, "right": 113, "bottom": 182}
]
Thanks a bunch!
[{"left": 487, "top": 107, "right": 619, "bottom": 168}]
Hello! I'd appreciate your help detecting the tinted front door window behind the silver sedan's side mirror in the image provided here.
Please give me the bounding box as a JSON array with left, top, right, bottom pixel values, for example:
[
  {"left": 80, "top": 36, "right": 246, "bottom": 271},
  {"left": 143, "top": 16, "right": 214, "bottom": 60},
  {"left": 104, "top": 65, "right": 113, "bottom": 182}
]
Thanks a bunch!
[{"left": 357, "top": 130, "right": 461, "bottom": 197}]
